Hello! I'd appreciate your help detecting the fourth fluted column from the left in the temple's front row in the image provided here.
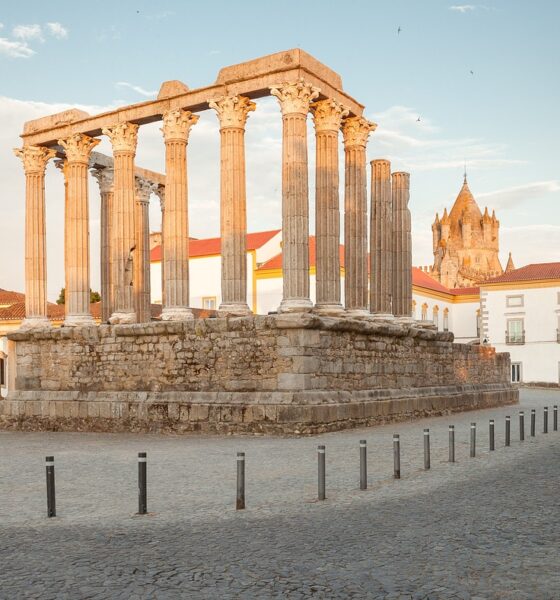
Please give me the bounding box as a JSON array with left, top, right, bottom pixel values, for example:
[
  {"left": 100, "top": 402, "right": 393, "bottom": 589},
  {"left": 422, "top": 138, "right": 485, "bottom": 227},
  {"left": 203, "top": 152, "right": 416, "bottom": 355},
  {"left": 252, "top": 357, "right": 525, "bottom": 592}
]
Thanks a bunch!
[{"left": 161, "top": 109, "right": 199, "bottom": 321}]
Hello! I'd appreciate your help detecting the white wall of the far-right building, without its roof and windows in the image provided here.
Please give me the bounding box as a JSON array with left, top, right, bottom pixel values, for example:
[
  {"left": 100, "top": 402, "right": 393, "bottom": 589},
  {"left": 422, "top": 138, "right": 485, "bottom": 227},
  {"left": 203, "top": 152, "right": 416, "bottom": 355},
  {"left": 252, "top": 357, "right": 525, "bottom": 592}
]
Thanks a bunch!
[{"left": 481, "top": 286, "right": 560, "bottom": 383}]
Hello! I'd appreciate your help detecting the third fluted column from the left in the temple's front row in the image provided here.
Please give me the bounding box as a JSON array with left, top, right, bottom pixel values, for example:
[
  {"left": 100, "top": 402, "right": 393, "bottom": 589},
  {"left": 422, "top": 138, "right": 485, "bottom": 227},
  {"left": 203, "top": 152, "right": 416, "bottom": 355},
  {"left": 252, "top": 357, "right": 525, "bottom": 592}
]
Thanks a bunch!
[{"left": 103, "top": 123, "right": 138, "bottom": 324}]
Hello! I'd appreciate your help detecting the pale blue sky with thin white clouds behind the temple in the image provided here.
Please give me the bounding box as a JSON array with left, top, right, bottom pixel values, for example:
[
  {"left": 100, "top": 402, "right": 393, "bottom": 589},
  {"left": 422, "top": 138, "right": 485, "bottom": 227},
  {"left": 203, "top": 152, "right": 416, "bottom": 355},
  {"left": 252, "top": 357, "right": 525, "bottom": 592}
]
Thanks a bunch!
[{"left": 0, "top": 0, "right": 560, "bottom": 300}]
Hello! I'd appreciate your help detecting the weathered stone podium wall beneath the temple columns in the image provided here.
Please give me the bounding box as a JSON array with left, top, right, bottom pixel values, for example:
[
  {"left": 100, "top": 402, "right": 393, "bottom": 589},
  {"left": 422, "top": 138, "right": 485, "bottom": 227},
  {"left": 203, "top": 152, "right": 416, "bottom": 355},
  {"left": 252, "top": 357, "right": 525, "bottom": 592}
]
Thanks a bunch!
[{"left": 0, "top": 315, "right": 518, "bottom": 433}]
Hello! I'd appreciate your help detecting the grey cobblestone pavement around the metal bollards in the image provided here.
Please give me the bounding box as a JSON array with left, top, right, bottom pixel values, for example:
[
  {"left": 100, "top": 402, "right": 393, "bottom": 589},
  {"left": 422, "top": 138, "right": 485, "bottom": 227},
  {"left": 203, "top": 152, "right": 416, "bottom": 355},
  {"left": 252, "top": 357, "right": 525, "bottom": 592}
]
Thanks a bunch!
[{"left": 0, "top": 390, "right": 560, "bottom": 600}]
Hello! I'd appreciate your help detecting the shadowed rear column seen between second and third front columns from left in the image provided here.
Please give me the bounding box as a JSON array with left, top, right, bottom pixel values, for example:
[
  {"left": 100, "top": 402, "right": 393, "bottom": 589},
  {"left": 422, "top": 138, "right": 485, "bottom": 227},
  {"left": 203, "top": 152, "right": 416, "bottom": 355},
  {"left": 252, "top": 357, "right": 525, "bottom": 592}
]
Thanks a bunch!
[{"left": 91, "top": 167, "right": 114, "bottom": 323}]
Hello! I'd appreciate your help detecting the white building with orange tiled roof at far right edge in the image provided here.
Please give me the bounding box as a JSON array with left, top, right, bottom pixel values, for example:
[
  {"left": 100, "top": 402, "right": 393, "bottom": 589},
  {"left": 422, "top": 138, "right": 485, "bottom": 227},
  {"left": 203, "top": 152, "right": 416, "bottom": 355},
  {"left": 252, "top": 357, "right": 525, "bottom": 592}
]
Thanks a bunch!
[{"left": 480, "top": 263, "right": 560, "bottom": 384}]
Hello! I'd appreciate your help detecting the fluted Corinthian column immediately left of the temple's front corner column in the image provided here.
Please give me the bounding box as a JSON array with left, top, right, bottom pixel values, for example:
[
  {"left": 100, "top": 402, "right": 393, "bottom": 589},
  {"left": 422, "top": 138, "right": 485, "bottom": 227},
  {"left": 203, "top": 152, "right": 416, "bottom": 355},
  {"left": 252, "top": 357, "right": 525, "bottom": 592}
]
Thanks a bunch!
[{"left": 208, "top": 96, "right": 255, "bottom": 315}]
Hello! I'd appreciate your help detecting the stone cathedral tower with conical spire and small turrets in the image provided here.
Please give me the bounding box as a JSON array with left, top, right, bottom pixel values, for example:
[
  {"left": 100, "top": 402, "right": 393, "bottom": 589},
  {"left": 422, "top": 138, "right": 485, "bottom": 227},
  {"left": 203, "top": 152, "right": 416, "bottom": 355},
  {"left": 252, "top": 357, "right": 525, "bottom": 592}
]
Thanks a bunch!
[{"left": 430, "top": 174, "right": 503, "bottom": 288}]
